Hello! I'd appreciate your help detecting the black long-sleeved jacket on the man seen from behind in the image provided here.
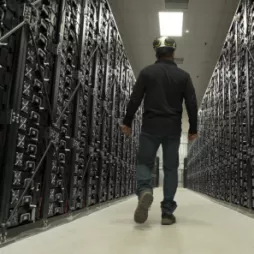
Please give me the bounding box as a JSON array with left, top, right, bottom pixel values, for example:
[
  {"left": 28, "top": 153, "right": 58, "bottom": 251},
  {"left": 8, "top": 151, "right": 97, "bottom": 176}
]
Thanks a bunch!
[{"left": 123, "top": 60, "right": 197, "bottom": 136}]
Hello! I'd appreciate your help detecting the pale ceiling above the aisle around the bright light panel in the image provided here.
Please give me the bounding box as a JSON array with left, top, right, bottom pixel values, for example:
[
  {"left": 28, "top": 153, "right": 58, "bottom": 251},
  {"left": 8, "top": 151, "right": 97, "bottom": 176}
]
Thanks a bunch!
[{"left": 109, "top": 0, "right": 239, "bottom": 129}]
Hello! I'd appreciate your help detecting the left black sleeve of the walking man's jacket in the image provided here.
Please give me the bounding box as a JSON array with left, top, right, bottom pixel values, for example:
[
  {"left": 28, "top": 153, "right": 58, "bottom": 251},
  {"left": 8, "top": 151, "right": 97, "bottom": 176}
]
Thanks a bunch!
[{"left": 123, "top": 72, "right": 145, "bottom": 127}]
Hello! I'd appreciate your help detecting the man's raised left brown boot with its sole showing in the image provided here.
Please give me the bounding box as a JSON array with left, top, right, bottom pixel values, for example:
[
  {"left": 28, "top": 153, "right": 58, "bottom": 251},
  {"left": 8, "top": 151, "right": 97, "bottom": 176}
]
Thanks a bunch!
[{"left": 134, "top": 190, "right": 153, "bottom": 224}]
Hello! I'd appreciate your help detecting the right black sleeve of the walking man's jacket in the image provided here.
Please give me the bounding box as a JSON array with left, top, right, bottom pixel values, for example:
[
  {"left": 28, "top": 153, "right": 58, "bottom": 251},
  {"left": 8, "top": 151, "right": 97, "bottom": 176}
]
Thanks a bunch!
[{"left": 184, "top": 75, "right": 198, "bottom": 134}]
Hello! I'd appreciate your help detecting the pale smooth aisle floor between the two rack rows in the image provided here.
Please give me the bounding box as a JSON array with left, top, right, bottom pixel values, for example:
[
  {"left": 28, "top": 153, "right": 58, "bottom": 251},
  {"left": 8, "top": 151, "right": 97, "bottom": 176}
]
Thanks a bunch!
[{"left": 0, "top": 189, "right": 254, "bottom": 254}]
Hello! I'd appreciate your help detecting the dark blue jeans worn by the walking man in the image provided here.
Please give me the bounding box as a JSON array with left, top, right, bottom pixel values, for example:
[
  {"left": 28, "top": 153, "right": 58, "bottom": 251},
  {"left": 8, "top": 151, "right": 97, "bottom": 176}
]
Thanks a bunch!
[{"left": 137, "top": 133, "right": 180, "bottom": 213}]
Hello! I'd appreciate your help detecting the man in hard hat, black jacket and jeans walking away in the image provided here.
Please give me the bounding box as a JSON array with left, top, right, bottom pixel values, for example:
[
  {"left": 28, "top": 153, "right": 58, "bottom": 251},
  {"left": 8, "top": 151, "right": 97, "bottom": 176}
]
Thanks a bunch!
[{"left": 121, "top": 37, "right": 197, "bottom": 225}]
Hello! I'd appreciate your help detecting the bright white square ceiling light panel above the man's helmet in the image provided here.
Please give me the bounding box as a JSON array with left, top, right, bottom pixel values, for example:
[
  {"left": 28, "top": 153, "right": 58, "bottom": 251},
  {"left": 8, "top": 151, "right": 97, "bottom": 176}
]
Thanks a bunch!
[{"left": 159, "top": 12, "right": 183, "bottom": 37}]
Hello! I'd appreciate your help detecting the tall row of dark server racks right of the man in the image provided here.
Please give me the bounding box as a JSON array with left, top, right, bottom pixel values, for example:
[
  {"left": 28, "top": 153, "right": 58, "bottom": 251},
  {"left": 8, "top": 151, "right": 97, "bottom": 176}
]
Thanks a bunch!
[{"left": 186, "top": 0, "right": 254, "bottom": 213}]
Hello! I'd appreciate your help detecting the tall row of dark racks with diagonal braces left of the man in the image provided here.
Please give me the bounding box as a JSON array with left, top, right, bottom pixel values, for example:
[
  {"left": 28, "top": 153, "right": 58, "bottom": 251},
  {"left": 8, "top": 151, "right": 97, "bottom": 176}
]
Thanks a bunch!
[{"left": 0, "top": 0, "right": 142, "bottom": 242}]
